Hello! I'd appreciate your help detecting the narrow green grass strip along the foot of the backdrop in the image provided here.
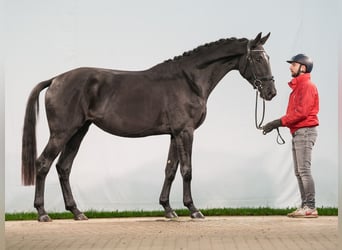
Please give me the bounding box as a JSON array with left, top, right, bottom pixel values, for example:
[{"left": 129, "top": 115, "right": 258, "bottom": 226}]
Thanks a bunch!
[{"left": 5, "top": 207, "right": 338, "bottom": 221}]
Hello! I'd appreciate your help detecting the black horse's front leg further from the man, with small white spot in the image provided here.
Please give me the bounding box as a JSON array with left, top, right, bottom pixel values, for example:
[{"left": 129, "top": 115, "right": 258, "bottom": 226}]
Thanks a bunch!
[{"left": 159, "top": 137, "right": 179, "bottom": 219}]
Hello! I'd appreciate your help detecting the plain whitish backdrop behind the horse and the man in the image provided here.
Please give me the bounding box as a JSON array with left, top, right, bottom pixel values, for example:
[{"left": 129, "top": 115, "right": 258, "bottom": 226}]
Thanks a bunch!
[{"left": 4, "top": 0, "right": 338, "bottom": 212}]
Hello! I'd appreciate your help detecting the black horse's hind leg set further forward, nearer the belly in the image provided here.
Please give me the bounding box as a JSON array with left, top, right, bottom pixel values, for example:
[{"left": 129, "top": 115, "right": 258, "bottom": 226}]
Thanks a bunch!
[{"left": 56, "top": 123, "right": 90, "bottom": 220}]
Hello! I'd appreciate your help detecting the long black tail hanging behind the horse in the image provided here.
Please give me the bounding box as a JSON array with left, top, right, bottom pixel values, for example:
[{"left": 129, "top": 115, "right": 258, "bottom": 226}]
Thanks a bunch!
[{"left": 21, "top": 79, "right": 52, "bottom": 186}]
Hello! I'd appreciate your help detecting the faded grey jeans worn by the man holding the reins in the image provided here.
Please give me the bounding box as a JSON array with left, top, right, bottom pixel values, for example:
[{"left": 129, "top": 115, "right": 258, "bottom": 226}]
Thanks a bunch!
[{"left": 292, "top": 127, "right": 317, "bottom": 208}]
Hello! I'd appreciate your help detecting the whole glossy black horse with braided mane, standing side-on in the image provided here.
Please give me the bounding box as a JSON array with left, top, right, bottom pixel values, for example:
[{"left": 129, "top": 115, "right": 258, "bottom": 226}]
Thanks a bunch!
[{"left": 22, "top": 33, "right": 276, "bottom": 221}]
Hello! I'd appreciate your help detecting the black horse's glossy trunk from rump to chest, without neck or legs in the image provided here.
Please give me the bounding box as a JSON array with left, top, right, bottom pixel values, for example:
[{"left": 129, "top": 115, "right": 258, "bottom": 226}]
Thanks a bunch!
[{"left": 46, "top": 68, "right": 203, "bottom": 137}]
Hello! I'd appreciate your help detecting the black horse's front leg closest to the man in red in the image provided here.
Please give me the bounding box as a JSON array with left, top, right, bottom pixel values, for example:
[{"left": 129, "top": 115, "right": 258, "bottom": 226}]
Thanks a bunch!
[{"left": 176, "top": 128, "right": 204, "bottom": 219}]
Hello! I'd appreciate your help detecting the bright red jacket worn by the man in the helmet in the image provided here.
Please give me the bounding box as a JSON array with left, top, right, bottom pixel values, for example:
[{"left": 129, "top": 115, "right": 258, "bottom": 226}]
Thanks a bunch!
[{"left": 281, "top": 73, "right": 319, "bottom": 134}]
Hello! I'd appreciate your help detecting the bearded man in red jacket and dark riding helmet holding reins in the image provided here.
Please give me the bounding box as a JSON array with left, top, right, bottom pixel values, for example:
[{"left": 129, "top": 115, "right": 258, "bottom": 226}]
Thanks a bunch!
[{"left": 263, "top": 54, "right": 319, "bottom": 218}]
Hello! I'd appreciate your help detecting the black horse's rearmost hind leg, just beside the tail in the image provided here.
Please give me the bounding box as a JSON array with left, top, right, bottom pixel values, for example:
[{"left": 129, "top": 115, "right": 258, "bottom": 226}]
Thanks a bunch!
[{"left": 34, "top": 135, "right": 67, "bottom": 222}]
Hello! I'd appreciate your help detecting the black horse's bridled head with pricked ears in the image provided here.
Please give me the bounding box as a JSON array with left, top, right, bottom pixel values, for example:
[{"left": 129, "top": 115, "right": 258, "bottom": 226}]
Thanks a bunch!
[{"left": 239, "top": 32, "right": 277, "bottom": 100}]
